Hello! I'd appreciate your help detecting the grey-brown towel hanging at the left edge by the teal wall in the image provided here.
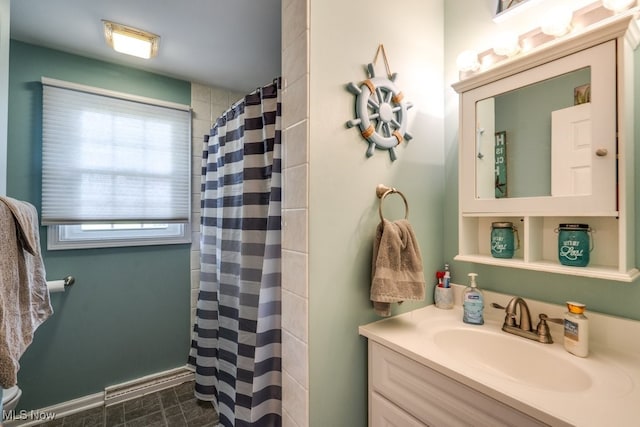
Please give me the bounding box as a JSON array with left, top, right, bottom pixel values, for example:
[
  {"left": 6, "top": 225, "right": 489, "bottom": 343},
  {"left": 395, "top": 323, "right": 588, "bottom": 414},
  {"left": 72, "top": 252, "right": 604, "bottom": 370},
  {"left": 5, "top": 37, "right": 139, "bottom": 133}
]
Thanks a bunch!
[{"left": 0, "top": 197, "right": 53, "bottom": 388}]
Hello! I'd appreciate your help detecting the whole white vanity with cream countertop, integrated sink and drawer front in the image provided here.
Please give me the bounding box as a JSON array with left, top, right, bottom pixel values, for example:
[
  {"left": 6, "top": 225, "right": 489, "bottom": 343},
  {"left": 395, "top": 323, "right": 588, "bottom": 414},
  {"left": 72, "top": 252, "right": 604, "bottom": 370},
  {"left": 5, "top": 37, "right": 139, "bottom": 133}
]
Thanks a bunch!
[{"left": 358, "top": 304, "right": 640, "bottom": 427}]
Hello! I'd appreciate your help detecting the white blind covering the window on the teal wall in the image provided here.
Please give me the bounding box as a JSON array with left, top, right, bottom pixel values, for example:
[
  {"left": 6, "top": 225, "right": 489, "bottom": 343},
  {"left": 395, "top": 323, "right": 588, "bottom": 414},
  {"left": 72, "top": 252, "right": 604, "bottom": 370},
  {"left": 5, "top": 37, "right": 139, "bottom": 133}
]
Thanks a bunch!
[{"left": 42, "top": 78, "right": 191, "bottom": 225}]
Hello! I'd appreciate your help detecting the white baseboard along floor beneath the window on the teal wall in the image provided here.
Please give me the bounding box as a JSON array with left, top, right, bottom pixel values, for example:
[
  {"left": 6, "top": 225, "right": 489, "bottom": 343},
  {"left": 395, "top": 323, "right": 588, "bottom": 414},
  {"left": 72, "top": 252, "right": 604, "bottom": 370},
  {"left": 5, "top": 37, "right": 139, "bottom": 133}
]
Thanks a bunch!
[{"left": 0, "top": 367, "right": 195, "bottom": 427}]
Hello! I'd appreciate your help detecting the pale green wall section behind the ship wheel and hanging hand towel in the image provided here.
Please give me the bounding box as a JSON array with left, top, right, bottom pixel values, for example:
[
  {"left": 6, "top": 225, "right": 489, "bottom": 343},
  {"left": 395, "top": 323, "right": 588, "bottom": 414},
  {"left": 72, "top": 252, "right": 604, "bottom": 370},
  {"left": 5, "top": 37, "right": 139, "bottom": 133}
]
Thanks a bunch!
[{"left": 310, "top": 0, "right": 445, "bottom": 427}]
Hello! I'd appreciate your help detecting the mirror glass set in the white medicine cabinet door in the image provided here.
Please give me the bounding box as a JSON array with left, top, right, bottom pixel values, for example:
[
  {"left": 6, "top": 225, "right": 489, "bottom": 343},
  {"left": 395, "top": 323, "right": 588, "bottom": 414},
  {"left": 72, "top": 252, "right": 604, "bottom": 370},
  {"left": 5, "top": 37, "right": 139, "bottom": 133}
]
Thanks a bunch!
[{"left": 475, "top": 67, "right": 592, "bottom": 199}]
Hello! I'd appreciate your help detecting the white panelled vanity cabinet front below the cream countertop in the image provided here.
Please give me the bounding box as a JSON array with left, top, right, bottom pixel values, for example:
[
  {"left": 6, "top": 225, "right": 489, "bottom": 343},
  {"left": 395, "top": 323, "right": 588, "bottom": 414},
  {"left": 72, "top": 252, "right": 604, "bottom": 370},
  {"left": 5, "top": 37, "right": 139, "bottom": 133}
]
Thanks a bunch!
[{"left": 369, "top": 340, "right": 547, "bottom": 427}]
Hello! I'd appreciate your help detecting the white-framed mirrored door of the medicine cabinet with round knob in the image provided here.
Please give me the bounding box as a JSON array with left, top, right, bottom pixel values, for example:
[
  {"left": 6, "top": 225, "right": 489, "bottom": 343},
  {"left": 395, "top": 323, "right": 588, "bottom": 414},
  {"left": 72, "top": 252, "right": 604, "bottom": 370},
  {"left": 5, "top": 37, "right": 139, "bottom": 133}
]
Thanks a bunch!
[{"left": 460, "top": 41, "right": 620, "bottom": 214}]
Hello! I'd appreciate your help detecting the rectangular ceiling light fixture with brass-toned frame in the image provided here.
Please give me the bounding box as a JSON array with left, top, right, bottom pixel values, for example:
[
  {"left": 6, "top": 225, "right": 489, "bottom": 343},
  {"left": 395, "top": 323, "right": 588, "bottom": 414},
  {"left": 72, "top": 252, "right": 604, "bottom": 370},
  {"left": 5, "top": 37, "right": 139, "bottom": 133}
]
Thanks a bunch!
[{"left": 102, "top": 20, "right": 160, "bottom": 59}]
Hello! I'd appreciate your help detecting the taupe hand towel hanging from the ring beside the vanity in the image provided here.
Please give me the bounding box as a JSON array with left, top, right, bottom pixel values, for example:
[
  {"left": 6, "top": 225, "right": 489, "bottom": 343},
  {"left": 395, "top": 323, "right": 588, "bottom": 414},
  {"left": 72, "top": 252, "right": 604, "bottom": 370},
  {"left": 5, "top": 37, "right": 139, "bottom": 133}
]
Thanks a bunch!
[{"left": 371, "top": 219, "right": 425, "bottom": 317}]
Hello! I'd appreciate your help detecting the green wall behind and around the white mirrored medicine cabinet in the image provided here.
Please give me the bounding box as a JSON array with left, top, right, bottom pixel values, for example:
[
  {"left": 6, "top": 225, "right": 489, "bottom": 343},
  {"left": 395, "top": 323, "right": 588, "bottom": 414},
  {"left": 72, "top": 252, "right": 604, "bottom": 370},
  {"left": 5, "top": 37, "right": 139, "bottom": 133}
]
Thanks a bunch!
[{"left": 444, "top": 0, "right": 640, "bottom": 320}]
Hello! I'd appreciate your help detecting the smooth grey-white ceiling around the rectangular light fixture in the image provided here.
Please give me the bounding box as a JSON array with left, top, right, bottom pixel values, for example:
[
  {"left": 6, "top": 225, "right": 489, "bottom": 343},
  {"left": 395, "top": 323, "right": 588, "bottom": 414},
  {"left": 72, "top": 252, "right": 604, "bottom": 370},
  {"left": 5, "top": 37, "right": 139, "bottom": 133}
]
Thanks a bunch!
[{"left": 11, "top": 0, "right": 281, "bottom": 92}]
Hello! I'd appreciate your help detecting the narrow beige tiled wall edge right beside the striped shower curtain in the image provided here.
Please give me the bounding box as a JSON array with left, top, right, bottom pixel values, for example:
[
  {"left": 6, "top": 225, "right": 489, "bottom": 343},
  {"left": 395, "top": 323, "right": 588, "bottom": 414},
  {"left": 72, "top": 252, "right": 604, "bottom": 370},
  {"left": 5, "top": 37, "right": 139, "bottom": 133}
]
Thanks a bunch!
[{"left": 282, "top": 0, "right": 309, "bottom": 427}]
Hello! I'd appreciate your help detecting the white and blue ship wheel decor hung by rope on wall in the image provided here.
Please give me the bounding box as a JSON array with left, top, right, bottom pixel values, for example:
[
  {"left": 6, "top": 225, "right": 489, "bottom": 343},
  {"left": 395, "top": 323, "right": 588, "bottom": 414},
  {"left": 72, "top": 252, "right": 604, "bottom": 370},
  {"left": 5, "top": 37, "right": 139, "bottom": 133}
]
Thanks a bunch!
[{"left": 347, "top": 45, "right": 413, "bottom": 160}]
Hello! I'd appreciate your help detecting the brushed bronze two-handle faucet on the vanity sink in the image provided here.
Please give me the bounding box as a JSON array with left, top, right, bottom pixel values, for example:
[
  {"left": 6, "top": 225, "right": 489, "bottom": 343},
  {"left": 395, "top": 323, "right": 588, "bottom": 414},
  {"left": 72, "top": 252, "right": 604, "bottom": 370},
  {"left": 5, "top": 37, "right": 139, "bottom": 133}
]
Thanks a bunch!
[{"left": 491, "top": 297, "right": 562, "bottom": 344}]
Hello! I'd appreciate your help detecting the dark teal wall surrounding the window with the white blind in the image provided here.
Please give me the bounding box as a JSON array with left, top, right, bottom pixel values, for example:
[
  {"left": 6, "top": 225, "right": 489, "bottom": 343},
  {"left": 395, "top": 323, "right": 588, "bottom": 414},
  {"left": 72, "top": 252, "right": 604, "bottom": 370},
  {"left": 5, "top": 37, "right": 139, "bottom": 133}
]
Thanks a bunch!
[{"left": 7, "top": 41, "right": 191, "bottom": 409}]
